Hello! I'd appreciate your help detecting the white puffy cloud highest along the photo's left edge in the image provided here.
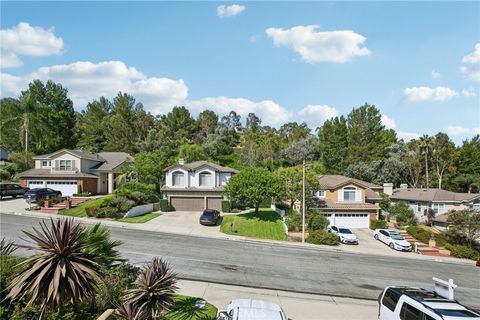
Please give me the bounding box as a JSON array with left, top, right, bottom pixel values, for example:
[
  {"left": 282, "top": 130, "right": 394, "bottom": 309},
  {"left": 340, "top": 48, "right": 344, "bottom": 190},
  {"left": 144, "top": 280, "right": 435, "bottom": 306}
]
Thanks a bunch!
[{"left": 0, "top": 22, "right": 63, "bottom": 68}]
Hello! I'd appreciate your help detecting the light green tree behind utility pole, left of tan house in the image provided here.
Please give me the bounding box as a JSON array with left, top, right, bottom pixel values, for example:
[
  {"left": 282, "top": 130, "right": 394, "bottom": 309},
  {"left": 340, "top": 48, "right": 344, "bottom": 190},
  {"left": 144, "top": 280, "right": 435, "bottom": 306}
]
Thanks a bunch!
[{"left": 275, "top": 165, "right": 320, "bottom": 208}]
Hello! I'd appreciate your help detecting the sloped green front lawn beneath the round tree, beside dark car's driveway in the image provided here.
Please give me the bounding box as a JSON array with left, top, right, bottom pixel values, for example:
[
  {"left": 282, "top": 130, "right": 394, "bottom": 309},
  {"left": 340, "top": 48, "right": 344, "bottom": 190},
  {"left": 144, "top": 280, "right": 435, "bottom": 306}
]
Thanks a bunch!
[{"left": 220, "top": 209, "right": 287, "bottom": 240}]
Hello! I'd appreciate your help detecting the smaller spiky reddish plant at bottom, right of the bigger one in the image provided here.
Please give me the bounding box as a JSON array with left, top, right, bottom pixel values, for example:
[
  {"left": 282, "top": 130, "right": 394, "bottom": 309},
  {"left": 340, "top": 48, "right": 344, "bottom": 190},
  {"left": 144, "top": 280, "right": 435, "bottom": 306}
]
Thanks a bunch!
[{"left": 125, "top": 258, "right": 178, "bottom": 319}]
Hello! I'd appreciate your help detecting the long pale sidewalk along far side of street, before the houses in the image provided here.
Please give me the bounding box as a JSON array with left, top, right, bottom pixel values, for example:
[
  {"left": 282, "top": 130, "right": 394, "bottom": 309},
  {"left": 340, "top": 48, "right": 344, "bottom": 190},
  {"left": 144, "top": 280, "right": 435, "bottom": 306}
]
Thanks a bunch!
[{"left": 0, "top": 206, "right": 474, "bottom": 265}]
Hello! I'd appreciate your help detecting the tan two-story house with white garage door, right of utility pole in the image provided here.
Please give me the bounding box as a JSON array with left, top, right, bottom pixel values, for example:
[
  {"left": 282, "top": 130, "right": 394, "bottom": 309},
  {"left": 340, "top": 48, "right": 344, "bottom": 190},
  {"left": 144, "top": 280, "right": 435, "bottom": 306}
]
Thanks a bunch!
[{"left": 312, "top": 175, "right": 382, "bottom": 229}]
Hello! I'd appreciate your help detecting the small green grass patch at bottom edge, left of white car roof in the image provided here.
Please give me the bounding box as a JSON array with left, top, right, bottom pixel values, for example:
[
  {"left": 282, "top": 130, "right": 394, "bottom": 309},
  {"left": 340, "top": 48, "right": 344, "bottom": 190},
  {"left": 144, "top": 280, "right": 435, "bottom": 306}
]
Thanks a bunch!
[{"left": 163, "top": 295, "right": 217, "bottom": 320}]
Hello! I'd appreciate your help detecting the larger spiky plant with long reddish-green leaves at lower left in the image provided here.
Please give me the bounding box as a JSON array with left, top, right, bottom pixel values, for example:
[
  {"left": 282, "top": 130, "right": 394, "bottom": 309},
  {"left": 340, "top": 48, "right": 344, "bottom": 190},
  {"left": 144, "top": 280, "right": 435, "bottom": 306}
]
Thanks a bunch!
[{"left": 6, "top": 219, "right": 100, "bottom": 317}]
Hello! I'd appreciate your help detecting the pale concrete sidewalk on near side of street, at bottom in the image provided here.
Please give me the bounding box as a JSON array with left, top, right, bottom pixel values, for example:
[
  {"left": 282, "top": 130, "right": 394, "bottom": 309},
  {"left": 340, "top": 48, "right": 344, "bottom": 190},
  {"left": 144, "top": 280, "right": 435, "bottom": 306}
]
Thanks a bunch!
[{"left": 179, "top": 280, "right": 378, "bottom": 320}]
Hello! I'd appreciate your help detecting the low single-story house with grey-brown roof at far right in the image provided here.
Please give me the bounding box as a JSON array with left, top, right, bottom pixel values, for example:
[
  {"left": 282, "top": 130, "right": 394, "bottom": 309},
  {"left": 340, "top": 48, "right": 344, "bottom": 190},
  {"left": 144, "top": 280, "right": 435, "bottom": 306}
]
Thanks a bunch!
[{"left": 385, "top": 184, "right": 480, "bottom": 222}]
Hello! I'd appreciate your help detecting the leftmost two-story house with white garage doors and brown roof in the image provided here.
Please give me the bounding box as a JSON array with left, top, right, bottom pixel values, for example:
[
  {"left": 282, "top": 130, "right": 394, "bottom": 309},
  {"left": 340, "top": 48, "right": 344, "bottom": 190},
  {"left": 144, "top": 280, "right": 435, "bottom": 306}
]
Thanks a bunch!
[{"left": 19, "top": 149, "right": 133, "bottom": 196}]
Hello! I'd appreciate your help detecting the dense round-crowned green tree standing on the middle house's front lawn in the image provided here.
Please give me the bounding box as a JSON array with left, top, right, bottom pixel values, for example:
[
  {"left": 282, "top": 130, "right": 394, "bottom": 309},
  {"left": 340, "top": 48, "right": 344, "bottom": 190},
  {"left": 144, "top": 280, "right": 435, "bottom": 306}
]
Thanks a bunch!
[{"left": 225, "top": 168, "right": 285, "bottom": 214}]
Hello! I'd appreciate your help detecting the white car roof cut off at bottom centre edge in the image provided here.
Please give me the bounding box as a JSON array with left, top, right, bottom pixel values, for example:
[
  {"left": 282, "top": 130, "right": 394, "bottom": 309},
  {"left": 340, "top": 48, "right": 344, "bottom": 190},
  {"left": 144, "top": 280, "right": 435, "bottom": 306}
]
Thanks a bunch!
[{"left": 217, "top": 299, "right": 288, "bottom": 320}]
